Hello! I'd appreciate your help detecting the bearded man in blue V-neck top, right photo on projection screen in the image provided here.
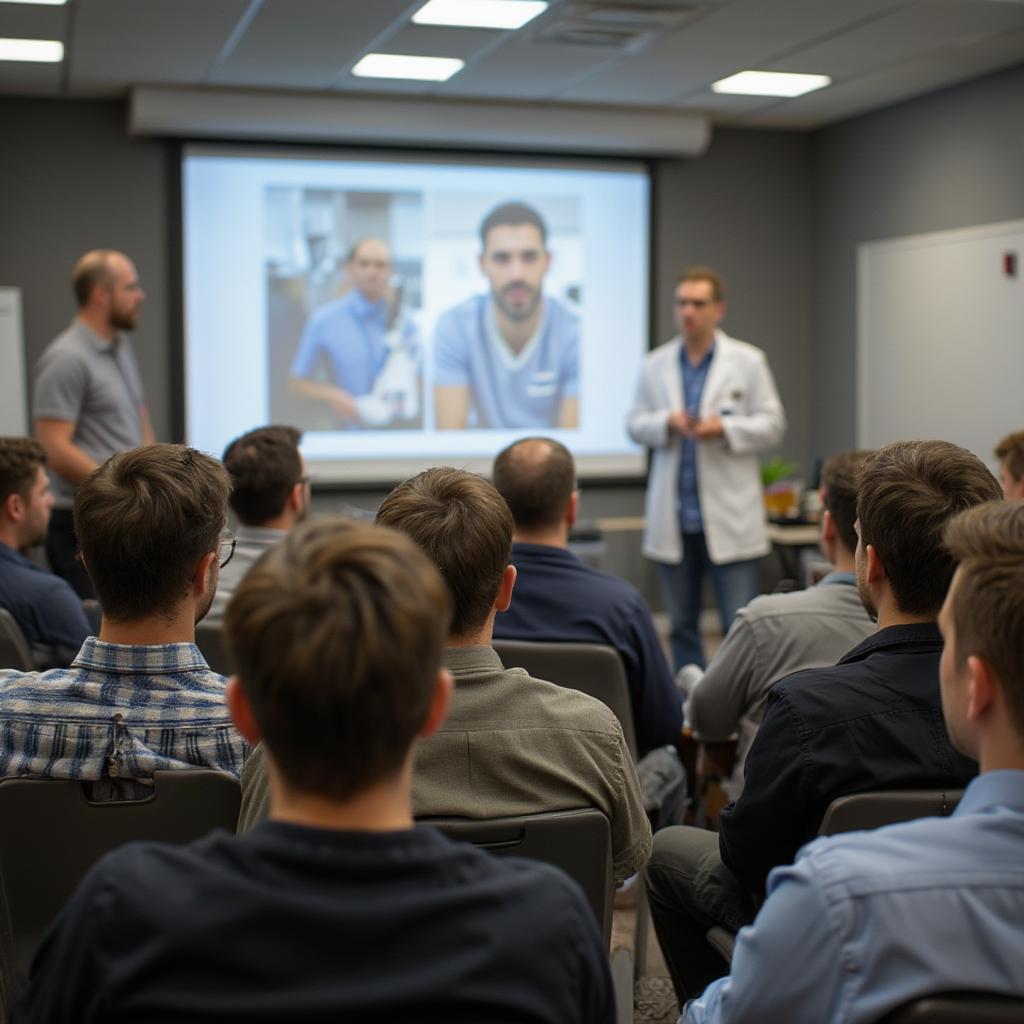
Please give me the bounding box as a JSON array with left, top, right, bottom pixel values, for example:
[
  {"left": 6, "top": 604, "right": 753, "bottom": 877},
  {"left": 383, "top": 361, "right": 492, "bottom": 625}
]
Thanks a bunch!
[{"left": 434, "top": 202, "right": 580, "bottom": 430}]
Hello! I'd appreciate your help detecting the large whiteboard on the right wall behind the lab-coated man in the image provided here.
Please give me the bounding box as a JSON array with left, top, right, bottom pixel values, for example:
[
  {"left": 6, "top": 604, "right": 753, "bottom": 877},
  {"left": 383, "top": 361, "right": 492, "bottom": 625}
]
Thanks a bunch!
[{"left": 857, "top": 220, "right": 1024, "bottom": 465}]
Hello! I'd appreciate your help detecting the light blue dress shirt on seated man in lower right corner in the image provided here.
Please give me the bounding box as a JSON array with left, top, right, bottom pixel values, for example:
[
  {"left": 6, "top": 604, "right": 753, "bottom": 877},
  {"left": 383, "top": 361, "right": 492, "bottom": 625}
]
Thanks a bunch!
[{"left": 680, "top": 771, "right": 1024, "bottom": 1024}]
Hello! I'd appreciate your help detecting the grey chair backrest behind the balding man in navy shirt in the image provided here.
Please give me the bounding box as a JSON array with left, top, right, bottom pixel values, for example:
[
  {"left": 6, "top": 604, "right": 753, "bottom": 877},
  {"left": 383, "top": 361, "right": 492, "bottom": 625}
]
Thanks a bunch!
[{"left": 494, "top": 640, "right": 637, "bottom": 761}]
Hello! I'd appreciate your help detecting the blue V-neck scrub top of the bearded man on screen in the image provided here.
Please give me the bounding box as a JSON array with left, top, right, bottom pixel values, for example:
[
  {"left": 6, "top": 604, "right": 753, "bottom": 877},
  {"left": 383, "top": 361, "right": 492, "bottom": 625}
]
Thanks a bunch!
[{"left": 434, "top": 295, "right": 580, "bottom": 428}]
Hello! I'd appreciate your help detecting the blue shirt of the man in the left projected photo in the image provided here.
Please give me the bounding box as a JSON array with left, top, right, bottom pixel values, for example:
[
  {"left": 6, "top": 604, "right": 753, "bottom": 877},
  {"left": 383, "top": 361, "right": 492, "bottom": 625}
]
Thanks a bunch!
[{"left": 292, "top": 288, "right": 416, "bottom": 397}]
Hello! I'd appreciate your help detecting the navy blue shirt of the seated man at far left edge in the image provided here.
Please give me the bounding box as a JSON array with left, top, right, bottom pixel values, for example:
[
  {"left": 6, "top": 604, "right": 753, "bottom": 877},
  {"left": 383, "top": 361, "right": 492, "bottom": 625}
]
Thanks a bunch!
[{"left": 0, "top": 544, "right": 93, "bottom": 668}]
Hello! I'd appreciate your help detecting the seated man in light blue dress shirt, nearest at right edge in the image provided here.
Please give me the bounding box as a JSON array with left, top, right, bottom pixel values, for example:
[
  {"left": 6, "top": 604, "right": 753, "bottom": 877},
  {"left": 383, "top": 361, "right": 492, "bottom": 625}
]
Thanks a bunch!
[{"left": 685, "top": 503, "right": 1024, "bottom": 1024}]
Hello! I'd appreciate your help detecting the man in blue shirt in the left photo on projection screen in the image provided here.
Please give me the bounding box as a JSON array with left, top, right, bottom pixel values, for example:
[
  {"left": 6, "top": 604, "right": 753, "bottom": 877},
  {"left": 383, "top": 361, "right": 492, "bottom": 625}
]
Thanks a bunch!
[{"left": 292, "top": 239, "right": 417, "bottom": 427}]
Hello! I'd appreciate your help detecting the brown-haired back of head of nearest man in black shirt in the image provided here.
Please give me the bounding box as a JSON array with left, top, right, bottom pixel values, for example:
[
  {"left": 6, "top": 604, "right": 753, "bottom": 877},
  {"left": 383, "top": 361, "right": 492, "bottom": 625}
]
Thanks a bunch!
[{"left": 224, "top": 517, "right": 451, "bottom": 801}]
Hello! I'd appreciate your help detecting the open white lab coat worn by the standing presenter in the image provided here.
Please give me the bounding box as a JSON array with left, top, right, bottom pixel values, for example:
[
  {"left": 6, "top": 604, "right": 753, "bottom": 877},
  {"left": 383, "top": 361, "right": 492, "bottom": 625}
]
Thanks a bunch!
[{"left": 629, "top": 331, "right": 785, "bottom": 565}]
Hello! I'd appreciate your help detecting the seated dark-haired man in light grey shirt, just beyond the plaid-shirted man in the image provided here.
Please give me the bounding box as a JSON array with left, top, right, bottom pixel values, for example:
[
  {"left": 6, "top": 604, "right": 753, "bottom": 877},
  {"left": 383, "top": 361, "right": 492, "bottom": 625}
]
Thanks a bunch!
[{"left": 207, "top": 427, "right": 309, "bottom": 622}]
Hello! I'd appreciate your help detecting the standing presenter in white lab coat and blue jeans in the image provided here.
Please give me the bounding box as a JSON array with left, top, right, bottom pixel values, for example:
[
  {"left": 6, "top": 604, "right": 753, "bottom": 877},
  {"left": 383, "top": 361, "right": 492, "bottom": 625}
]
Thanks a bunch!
[{"left": 629, "top": 267, "right": 785, "bottom": 671}]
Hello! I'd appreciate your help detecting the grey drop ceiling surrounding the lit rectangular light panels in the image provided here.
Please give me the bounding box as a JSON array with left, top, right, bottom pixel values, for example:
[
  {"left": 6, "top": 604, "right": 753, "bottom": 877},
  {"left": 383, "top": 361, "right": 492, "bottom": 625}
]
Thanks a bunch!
[{"left": 0, "top": 0, "right": 1024, "bottom": 129}]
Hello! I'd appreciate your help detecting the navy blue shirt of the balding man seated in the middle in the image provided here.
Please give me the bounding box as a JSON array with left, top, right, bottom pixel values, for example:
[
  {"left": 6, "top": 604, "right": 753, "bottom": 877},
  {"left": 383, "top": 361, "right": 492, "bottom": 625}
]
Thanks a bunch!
[{"left": 495, "top": 543, "right": 683, "bottom": 757}]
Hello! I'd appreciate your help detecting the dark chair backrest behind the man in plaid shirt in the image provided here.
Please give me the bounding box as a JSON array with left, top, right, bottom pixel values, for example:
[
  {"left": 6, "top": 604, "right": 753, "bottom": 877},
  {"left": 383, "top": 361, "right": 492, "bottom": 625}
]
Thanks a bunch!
[{"left": 0, "top": 769, "right": 242, "bottom": 973}]
